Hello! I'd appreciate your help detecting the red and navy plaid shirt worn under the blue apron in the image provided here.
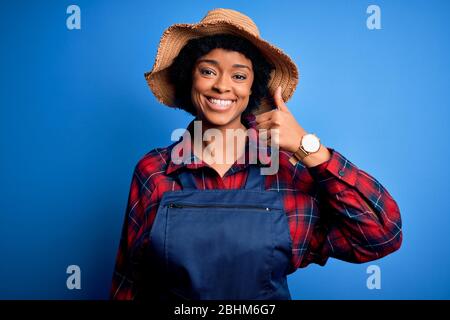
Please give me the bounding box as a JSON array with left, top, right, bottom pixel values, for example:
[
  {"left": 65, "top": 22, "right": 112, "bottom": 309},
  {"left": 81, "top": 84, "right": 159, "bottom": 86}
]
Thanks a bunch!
[{"left": 110, "top": 116, "right": 402, "bottom": 299}]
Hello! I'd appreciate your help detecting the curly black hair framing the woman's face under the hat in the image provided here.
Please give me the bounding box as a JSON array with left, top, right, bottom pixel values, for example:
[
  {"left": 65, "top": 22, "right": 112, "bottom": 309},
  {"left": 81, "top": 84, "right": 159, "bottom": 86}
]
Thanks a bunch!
[{"left": 169, "top": 34, "right": 274, "bottom": 116}]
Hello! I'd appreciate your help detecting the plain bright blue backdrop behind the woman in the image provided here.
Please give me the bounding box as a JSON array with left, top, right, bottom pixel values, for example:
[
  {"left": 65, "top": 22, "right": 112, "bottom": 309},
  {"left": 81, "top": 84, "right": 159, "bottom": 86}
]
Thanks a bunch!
[{"left": 0, "top": 0, "right": 450, "bottom": 299}]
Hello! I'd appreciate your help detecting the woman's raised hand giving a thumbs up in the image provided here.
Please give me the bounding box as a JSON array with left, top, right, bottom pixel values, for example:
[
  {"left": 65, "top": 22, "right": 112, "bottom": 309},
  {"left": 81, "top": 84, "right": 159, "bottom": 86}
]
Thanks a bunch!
[{"left": 256, "top": 87, "right": 307, "bottom": 152}]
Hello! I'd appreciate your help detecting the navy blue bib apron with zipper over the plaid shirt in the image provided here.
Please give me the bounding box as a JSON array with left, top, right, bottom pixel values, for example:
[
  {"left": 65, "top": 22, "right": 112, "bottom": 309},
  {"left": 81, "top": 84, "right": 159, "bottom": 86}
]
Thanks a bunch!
[{"left": 149, "top": 165, "right": 293, "bottom": 300}]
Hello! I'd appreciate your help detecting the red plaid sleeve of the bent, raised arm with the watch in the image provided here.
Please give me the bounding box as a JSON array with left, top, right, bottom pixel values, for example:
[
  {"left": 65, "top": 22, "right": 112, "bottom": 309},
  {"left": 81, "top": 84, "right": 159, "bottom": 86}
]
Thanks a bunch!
[{"left": 299, "top": 148, "right": 402, "bottom": 268}]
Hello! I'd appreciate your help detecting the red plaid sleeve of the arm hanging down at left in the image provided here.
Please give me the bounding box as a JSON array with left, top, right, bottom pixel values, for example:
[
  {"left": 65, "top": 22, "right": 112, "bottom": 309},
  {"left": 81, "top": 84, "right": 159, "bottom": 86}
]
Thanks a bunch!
[{"left": 110, "top": 166, "right": 150, "bottom": 300}]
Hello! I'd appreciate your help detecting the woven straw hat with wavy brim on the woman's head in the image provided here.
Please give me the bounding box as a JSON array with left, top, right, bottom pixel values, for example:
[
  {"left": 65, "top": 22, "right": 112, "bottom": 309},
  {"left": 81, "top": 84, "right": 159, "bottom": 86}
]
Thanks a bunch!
[{"left": 145, "top": 9, "right": 299, "bottom": 113}]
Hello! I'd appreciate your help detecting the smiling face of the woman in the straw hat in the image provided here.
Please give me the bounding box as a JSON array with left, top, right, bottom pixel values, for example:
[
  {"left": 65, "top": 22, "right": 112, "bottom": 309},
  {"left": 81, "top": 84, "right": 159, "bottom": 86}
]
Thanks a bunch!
[{"left": 191, "top": 49, "right": 253, "bottom": 128}]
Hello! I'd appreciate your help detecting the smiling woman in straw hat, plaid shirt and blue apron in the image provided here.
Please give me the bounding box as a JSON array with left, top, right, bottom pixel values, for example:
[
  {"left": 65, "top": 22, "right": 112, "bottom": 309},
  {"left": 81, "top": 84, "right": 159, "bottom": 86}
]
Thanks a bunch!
[{"left": 111, "top": 9, "right": 402, "bottom": 300}]
